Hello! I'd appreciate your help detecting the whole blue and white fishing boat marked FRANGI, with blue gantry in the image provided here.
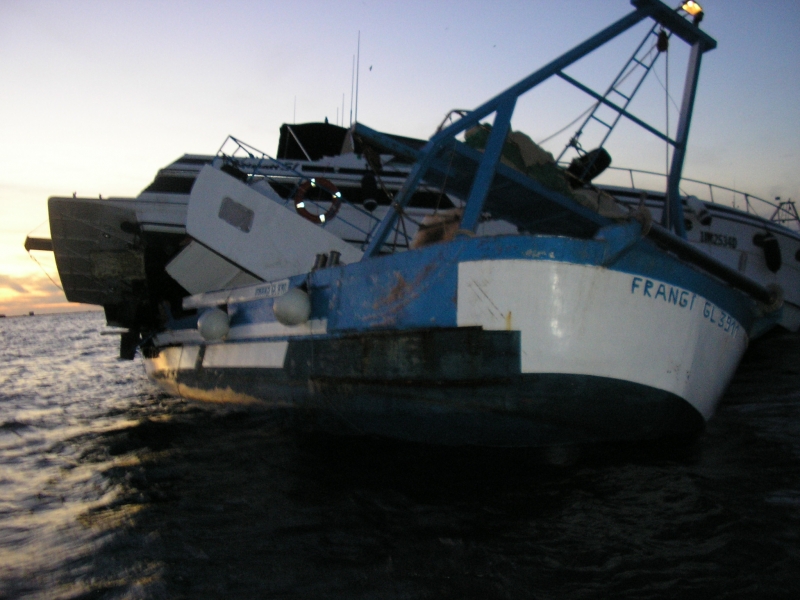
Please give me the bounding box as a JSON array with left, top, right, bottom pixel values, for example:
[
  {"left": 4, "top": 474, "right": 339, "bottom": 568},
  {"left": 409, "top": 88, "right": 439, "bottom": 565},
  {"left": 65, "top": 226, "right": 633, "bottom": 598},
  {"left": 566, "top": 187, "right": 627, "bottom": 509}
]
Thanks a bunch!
[{"left": 32, "top": 0, "right": 796, "bottom": 446}]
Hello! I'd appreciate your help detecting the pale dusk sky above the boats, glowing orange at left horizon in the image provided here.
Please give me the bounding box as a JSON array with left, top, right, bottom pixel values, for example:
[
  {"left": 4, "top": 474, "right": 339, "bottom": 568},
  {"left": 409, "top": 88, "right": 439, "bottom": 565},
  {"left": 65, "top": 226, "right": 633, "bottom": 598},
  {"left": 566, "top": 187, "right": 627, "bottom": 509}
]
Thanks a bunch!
[{"left": 0, "top": 0, "right": 800, "bottom": 316}]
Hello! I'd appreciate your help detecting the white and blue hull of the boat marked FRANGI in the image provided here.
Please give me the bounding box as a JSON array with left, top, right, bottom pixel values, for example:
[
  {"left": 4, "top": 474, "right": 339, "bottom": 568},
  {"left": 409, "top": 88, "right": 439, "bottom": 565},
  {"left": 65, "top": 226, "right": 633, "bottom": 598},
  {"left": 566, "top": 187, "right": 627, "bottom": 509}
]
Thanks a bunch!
[{"left": 145, "top": 236, "right": 764, "bottom": 446}]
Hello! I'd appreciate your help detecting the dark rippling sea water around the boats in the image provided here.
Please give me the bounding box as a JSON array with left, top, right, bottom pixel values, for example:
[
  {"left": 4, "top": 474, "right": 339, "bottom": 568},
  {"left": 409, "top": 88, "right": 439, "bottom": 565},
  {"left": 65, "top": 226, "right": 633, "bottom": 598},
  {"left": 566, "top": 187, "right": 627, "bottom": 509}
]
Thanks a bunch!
[{"left": 0, "top": 313, "right": 800, "bottom": 599}]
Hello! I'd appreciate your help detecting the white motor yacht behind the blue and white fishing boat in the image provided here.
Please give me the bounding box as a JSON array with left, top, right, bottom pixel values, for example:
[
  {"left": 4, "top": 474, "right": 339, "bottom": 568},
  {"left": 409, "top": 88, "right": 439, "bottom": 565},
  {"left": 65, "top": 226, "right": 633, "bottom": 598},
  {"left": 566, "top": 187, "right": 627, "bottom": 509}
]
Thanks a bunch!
[{"left": 36, "top": 118, "right": 800, "bottom": 346}]
